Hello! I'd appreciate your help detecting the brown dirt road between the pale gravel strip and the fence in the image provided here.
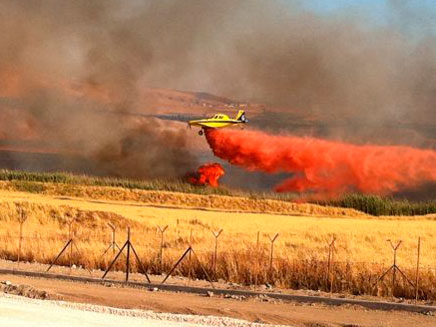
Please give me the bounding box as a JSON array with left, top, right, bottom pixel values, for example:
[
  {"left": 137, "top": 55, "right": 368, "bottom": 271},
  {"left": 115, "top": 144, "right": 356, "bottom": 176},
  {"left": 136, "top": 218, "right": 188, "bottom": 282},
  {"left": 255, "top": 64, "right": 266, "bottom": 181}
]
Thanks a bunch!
[{"left": 0, "top": 275, "right": 436, "bottom": 327}]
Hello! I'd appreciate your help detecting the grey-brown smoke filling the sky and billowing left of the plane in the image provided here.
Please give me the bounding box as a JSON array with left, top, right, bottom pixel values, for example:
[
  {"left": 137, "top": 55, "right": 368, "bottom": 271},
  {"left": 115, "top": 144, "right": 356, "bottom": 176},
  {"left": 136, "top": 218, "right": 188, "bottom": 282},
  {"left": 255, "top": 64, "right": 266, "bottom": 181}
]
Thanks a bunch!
[{"left": 0, "top": 0, "right": 436, "bottom": 187}]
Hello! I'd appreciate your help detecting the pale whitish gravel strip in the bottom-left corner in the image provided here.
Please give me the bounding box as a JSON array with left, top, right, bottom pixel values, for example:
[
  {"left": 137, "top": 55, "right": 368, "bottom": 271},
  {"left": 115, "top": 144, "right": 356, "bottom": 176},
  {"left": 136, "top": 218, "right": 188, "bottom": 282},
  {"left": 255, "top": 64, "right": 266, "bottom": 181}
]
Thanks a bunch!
[{"left": 0, "top": 295, "right": 272, "bottom": 327}]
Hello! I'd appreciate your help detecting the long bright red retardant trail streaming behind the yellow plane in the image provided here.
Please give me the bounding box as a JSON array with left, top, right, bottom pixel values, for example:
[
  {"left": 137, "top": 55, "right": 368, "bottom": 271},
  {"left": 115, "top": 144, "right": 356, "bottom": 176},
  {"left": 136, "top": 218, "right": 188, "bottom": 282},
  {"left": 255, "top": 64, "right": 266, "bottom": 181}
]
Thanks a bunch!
[{"left": 206, "top": 129, "right": 436, "bottom": 196}]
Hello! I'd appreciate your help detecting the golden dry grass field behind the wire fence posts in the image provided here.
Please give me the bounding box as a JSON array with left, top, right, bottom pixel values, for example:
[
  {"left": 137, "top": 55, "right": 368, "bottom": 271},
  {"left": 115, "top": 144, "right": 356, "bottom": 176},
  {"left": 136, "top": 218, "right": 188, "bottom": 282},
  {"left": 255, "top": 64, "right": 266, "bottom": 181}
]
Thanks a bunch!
[{"left": 0, "top": 182, "right": 436, "bottom": 300}]
